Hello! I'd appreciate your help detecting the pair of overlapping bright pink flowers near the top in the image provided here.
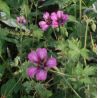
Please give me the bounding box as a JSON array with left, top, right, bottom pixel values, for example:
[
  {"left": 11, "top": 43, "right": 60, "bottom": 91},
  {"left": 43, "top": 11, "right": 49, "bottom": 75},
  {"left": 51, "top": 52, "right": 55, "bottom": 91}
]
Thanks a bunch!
[{"left": 39, "top": 11, "right": 68, "bottom": 31}]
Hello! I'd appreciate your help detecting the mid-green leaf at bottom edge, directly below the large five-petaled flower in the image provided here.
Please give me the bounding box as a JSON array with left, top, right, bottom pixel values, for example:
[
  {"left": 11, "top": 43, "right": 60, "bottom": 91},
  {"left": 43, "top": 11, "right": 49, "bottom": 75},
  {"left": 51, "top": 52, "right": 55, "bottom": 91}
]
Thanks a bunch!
[{"left": 35, "top": 83, "right": 52, "bottom": 98}]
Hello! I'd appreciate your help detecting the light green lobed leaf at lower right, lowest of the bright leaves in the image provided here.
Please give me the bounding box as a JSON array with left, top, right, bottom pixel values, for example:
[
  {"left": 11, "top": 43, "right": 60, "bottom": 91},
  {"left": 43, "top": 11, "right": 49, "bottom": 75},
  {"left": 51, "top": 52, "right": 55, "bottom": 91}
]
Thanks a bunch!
[{"left": 72, "top": 63, "right": 96, "bottom": 84}]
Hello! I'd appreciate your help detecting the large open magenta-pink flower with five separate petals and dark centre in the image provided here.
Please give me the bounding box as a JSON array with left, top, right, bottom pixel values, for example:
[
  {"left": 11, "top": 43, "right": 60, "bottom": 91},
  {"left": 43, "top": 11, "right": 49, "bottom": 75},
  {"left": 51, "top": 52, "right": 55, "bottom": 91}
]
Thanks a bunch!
[{"left": 27, "top": 48, "right": 57, "bottom": 81}]
